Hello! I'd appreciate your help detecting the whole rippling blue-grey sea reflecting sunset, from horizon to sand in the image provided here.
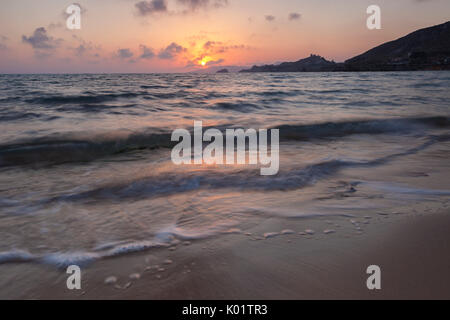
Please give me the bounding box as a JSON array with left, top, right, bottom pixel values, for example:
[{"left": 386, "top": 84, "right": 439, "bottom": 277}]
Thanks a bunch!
[{"left": 0, "top": 71, "right": 450, "bottom": 267}]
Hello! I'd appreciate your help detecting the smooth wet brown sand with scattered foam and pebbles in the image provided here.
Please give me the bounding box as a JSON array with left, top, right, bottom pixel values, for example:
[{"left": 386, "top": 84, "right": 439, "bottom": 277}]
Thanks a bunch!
[{"left": 0, "top": 202, "right": 450, "bottom": 299}]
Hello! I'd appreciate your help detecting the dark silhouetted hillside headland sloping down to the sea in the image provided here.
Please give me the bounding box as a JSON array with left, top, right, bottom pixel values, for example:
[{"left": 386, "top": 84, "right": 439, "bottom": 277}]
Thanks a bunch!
[{"left": 239, "top": 21, "right": 450, "bottom": 73}]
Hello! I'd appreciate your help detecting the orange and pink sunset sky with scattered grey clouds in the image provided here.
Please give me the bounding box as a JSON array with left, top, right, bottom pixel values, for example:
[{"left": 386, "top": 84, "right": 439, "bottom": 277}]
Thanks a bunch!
[{"left": 0, "top": 0, "right": 450, "bottom": 73}]
